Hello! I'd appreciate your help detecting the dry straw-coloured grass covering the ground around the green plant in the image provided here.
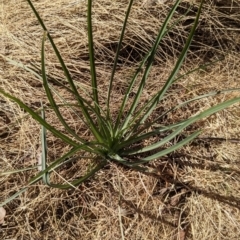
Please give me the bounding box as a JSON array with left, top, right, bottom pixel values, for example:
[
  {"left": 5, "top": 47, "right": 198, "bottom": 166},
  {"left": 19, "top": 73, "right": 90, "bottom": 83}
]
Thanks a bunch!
[{"left": 0, "top": 0, "right": 240, "bottom": 240}]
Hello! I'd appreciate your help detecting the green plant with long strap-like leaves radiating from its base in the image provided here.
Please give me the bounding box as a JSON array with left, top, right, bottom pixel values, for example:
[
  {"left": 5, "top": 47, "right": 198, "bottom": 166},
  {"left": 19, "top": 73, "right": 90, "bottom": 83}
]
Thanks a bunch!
[{"left": 0, "top": 0, "right": 240, "bottom": 206}]
